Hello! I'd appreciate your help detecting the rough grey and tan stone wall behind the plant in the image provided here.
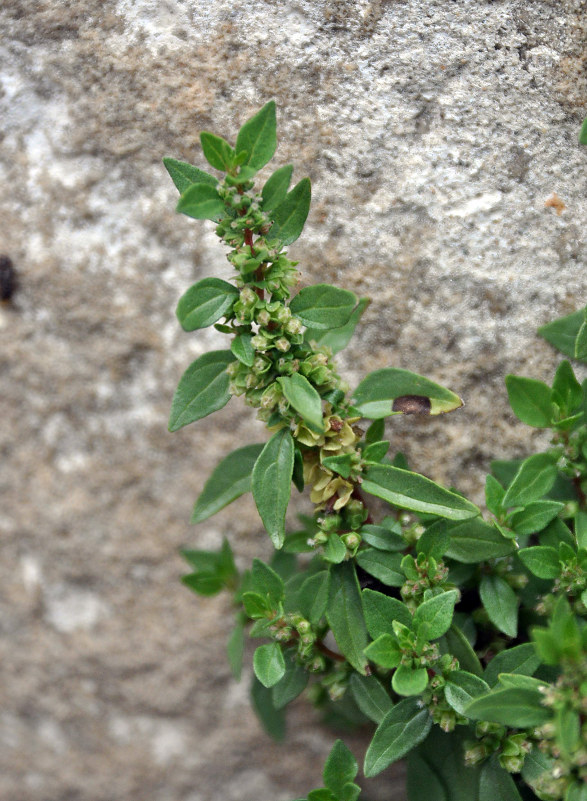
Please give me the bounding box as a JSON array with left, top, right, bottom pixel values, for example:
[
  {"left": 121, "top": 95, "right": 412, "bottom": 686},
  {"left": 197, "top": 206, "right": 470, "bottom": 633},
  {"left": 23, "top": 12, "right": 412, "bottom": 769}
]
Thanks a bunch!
[{"left": 0, "top": 0, "right": 587, "bottom": 801}]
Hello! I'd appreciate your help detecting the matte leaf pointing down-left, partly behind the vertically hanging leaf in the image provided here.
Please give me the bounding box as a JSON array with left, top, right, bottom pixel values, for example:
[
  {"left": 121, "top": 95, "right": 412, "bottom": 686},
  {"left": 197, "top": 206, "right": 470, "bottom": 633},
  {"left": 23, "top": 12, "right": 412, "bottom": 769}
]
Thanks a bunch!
[{"left": 191, "top": 445, "right": 263, "bottom": 523}]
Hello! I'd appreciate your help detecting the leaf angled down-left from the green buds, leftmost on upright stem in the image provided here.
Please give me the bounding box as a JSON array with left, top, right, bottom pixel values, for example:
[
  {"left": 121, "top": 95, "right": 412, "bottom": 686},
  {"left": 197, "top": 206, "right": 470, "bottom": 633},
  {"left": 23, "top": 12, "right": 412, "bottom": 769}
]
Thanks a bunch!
[{"left": 169, "top": 350, "right": 234, "bottom": 431}]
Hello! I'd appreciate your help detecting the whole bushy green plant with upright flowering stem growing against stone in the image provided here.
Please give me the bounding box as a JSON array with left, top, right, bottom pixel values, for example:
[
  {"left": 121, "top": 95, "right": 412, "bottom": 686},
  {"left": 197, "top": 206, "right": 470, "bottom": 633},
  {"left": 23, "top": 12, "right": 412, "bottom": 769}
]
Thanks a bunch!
[{"left": 165, "top": 102, "right": 587, "bottom": 801}]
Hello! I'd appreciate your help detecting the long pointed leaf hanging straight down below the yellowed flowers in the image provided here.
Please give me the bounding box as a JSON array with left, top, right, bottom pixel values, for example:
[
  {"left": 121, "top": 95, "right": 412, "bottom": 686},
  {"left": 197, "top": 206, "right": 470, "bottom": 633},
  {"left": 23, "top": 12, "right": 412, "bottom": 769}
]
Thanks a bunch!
[{"left": 251, "top": 428, "right": 294, "bottom": 548}]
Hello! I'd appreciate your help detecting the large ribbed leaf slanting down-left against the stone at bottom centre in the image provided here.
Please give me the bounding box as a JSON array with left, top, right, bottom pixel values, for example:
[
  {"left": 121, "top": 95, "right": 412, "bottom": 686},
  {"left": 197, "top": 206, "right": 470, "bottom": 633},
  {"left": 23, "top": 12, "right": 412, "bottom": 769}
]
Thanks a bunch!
[{"left": 364, "top": 698, "right": 432, "bottom": 778}]
